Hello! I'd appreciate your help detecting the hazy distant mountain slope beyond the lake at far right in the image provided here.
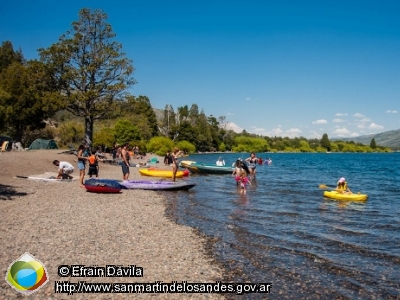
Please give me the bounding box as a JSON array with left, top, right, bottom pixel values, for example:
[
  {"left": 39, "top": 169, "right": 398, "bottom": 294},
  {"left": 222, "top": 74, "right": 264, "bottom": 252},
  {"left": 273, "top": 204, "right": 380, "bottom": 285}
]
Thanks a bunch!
[{"left": 332, "top": 129, "right": 400, "bottom": 149}]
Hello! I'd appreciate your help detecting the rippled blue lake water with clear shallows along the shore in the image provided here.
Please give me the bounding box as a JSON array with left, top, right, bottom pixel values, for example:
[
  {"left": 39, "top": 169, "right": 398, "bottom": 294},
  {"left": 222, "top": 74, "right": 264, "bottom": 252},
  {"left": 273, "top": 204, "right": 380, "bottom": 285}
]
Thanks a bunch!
[{"left": 167, "top": 153, "right": 400, "bottom": 299}]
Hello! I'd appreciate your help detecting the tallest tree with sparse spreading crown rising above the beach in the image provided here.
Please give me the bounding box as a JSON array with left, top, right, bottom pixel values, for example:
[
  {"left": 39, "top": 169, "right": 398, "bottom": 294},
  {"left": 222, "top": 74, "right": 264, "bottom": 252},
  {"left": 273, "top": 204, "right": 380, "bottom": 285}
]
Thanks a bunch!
[{"left": 39, "top": 8, "right": 135, "bottom": 143}]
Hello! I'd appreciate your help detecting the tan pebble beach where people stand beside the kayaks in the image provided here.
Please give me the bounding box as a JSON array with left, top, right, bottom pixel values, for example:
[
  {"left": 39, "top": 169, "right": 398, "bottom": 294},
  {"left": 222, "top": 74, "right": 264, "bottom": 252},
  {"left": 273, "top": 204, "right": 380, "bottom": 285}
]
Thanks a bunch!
[{"left": 0, "top": 150, "right": 222, "bottom": 299}]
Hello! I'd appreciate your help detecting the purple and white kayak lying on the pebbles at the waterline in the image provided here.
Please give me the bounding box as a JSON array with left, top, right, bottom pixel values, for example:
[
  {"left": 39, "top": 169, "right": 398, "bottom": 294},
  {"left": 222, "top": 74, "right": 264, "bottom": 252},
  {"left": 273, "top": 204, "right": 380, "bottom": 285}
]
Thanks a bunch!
[{"left": 120, "top": 180, "right": 196, "bottom": 191}]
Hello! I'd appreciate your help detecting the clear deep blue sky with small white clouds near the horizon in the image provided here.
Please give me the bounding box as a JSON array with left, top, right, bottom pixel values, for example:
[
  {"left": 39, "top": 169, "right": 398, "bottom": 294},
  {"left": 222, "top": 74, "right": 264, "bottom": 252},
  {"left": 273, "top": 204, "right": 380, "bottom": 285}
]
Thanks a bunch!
[{"left": 0, "top": 0, "right": 400, "bottom": 138}]
